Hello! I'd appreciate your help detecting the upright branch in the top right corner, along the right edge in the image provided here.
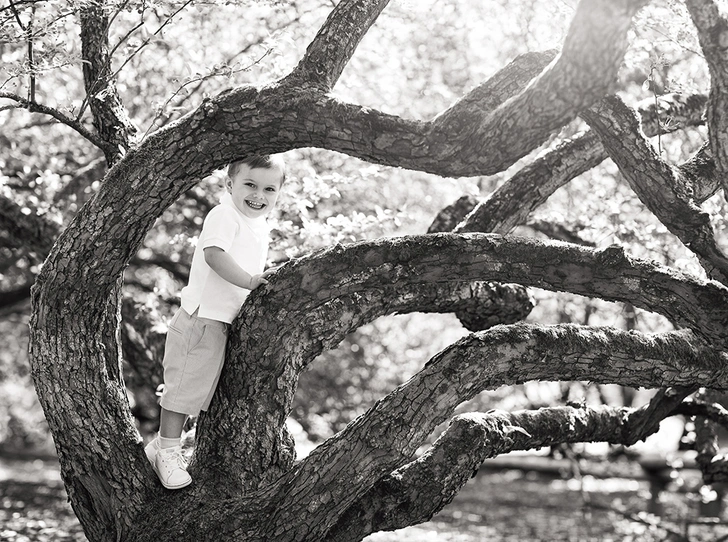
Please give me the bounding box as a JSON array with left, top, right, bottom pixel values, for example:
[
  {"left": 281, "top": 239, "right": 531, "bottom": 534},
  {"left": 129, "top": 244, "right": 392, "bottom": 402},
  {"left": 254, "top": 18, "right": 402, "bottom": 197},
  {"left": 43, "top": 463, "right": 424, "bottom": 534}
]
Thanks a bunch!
[{"left": 685, "top": 0, "right": 728, "bottom": 183}]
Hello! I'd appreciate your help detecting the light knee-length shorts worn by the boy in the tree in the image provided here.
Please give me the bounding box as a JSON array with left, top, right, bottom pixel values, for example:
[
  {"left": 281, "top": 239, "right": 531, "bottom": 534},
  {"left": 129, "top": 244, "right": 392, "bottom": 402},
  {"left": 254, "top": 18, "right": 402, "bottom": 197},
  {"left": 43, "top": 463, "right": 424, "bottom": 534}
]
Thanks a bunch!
[{"left": 160, "top": 308, "right": 228, "bottom": 416}]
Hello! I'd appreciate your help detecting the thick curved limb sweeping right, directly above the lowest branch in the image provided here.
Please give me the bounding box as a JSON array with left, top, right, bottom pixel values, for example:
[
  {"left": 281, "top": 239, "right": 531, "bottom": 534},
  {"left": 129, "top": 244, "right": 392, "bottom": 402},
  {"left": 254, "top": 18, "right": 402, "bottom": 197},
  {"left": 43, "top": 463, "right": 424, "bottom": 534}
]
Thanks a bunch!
[{"left": 274, "top": 324, "right": 728, "bottom": 537}]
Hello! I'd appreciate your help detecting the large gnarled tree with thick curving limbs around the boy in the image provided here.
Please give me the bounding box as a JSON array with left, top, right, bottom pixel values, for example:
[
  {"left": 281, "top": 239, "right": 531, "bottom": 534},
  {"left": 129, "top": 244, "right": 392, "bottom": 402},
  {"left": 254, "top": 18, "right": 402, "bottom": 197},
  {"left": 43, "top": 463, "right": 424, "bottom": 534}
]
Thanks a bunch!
[{"left": 3, "top": 0, "right": 728, "bottom": 541}]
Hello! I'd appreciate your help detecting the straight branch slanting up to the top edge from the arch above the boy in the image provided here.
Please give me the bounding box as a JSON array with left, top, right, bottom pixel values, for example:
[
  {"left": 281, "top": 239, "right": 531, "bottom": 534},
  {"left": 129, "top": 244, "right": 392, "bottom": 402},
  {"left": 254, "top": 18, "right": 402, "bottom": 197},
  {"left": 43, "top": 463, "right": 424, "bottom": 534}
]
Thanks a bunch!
[{"left": 284, "top": 0, "right": 389, "bottom": 91}]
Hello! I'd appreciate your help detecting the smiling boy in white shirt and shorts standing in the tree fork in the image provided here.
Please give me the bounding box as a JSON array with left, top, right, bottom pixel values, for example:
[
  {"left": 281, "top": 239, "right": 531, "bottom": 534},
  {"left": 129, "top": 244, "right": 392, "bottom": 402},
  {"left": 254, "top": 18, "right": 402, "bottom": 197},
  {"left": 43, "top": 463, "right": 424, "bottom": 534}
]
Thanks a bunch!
[{"left": 144, "top": 156, "right": 286, "bottom": 489}]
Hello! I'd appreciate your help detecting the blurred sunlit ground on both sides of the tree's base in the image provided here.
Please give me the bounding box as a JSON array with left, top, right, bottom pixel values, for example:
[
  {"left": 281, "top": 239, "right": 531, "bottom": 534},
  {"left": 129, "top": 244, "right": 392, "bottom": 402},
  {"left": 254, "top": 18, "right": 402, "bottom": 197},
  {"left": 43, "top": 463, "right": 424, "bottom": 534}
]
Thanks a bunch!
[{"left": 0, "top": 458, "right": 728, "bottom": 542}]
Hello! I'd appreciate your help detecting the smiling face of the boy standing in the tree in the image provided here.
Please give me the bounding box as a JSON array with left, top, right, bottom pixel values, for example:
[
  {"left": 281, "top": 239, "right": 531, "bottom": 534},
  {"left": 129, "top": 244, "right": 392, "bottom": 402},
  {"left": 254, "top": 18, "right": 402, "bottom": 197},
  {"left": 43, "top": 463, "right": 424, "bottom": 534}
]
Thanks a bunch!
[{"left": 225, "top": 164, "right": 283, "bottom": 218}]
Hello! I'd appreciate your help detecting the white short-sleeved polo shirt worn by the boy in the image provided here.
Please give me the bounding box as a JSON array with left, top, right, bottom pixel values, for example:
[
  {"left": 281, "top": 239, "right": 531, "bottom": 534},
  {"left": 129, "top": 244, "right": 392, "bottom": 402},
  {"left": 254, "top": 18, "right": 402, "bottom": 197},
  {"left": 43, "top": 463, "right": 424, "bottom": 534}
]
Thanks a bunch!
[{"left": 180, "top": 194, "right": 270, "bottom": 324}]
